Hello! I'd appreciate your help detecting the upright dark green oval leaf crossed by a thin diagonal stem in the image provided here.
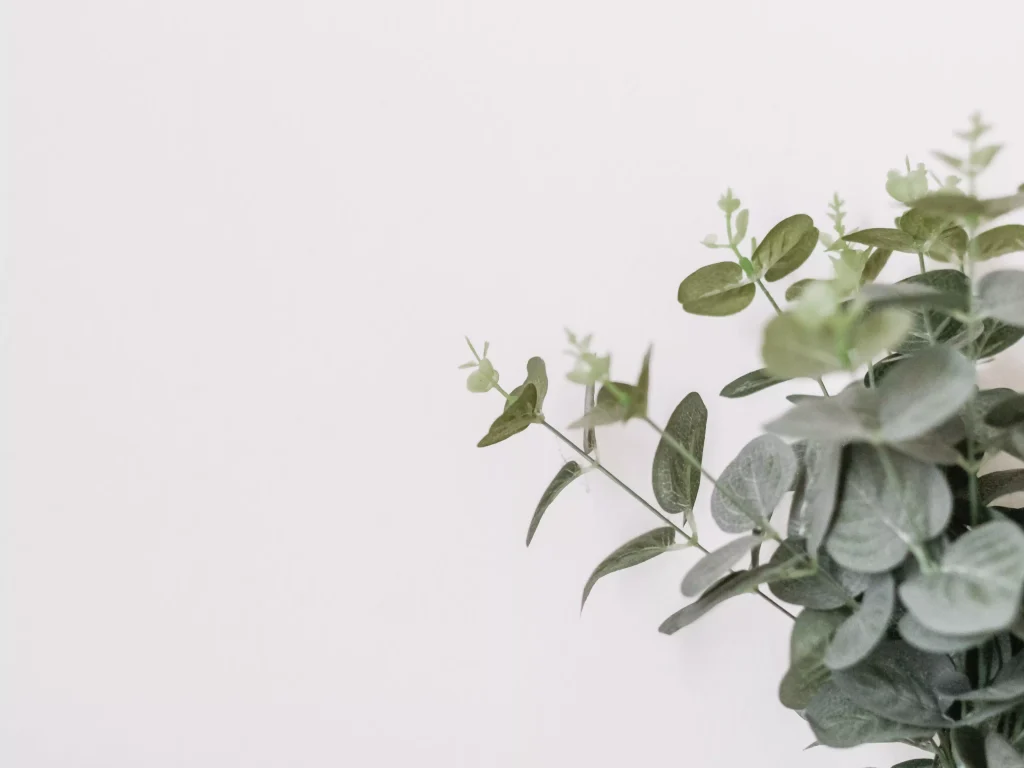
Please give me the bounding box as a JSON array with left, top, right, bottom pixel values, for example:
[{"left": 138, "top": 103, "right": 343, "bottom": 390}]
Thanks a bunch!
[{"left": 651, "top": 392, "right": 708, "bottom": 520}]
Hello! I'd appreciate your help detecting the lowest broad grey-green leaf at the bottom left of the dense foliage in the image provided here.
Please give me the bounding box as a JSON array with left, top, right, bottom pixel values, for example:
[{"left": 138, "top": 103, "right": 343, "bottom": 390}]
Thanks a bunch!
[{"left": 805, "top": 682, "right": 935, "bottom": 749}]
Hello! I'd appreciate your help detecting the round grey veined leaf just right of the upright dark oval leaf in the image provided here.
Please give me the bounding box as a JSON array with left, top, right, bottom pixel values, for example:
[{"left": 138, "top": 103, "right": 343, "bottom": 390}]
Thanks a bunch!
[{"left": 711, "top": 435, "right": 797, "bottom": 534}]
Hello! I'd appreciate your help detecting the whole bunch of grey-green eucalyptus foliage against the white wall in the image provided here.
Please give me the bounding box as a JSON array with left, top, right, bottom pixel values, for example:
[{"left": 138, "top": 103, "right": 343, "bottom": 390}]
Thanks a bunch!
[{"left": 467, "top": 115, "right": 1024, "bottom": 768}]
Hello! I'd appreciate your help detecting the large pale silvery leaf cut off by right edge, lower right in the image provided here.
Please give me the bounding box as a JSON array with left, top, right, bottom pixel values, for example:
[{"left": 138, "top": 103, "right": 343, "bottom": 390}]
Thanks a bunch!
[{"left": 899, "top": 521, "right": 1024, "bottom": 636}]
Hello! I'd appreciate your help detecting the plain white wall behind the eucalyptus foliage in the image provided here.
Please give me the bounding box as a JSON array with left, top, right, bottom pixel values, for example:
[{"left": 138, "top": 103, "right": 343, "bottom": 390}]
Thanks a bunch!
[{"left": 6, "top": 0, "right": 1024, "bottom": 768}]
